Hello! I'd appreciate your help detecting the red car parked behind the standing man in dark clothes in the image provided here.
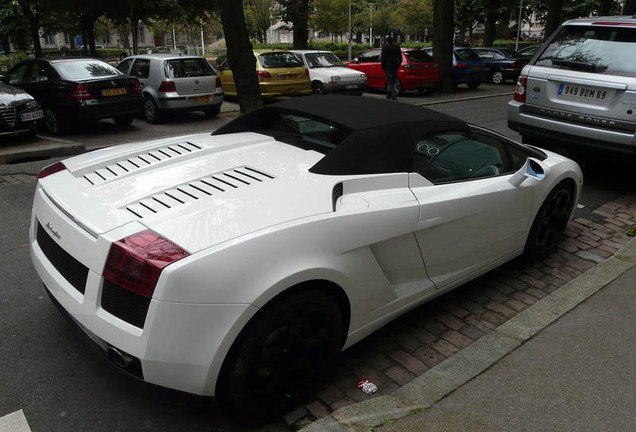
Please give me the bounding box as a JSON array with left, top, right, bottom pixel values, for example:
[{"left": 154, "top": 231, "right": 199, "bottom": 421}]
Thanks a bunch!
[{"left": 347, "top": 48, "right": 439, "bottom": 94}]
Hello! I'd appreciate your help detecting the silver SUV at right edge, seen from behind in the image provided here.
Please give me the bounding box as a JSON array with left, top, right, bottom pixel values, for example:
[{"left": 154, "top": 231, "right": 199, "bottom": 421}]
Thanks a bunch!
[{"left": 508, "top": 17, "right": 636, "bottom": 153}]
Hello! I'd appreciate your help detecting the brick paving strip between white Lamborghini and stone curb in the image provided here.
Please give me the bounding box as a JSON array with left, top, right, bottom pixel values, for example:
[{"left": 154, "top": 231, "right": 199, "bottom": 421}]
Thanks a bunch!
[{"left": 285, "top": 195, "right": 636, "bottom": 427}]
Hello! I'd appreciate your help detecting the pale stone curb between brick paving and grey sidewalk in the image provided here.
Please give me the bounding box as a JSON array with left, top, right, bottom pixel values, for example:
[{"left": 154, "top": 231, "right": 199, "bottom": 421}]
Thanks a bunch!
[{"left": 303, "top": 239, "right": 636, "bottom": 432}]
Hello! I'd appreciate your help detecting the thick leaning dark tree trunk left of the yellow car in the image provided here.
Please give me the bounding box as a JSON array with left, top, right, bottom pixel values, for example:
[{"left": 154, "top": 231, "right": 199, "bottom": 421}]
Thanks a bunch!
[{"left": 221, "top": 0, "right": 263, "bottom": 113}]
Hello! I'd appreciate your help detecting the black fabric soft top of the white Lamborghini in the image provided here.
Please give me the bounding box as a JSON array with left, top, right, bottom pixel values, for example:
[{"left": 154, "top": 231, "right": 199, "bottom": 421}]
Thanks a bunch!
[{"left": 213, "top": 95, "right": 468, "bottom": 175}]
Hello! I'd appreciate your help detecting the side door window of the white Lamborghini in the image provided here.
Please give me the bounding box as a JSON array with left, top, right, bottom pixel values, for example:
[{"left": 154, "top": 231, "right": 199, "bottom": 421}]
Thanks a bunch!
[{"left": 413, "top": 132, "right": 511, "bottom": 184}]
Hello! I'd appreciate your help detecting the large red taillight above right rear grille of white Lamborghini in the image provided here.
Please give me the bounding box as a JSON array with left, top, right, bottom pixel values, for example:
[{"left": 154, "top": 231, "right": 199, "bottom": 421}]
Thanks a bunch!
[{"left": 103, "top": 230, "right": 190, "bottom": 298}]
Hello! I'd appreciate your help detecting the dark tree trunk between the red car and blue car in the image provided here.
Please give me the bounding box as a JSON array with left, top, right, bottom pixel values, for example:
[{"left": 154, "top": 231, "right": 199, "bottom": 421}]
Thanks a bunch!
[{"left": 433, "top": 0, "right": 455, "bottom": 93}]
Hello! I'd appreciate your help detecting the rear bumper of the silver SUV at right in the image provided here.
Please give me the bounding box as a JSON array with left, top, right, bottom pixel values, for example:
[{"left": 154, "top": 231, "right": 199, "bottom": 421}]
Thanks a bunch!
[{"left": 508, "top": 101, "right": 636, "bottom": 154}]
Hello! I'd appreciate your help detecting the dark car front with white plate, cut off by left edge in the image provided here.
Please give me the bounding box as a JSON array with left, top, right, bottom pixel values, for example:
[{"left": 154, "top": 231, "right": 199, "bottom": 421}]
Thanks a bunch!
[{"left": 0, "top": 82, "right": 44, "bottom": 135}]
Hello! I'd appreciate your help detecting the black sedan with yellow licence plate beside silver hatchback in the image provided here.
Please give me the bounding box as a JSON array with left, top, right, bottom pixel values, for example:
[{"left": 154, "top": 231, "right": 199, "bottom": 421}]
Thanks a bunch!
[{"left": 2, "top": 57, "right": 143, "bottom": 134}]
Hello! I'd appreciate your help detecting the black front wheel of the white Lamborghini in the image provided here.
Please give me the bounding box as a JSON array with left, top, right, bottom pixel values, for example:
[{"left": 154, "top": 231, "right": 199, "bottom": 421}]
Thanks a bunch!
[{"left": 525, "top": 182, "right": 574, "bottom": 258}]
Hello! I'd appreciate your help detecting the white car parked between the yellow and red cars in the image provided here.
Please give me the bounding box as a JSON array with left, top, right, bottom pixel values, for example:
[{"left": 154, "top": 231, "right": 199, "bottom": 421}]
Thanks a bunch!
[{"left": 292, "top": 50, "right": 369, "bottom": 95}]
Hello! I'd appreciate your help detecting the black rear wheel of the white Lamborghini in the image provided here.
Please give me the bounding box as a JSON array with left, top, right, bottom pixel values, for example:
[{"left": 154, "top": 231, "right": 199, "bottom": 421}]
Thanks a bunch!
[{"left": 217, "top": 287, "right": 346, "bottom": 419}]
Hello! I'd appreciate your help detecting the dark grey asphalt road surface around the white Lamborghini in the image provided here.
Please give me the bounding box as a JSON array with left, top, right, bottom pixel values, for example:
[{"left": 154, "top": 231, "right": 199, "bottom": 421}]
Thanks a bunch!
[{"left": 0, "top": 86, "right": 636, "bottom": 432}]
